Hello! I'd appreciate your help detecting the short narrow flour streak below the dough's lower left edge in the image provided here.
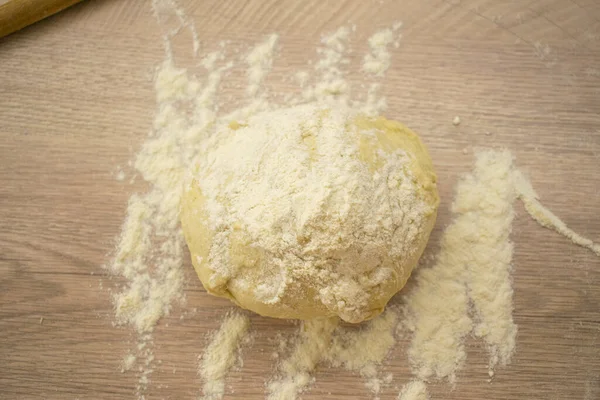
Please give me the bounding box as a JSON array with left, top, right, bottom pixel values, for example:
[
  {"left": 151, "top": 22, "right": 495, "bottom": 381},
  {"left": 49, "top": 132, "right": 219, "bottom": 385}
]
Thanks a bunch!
[{"left": 198, "top": 312, "right": 250, "bottom": 400}]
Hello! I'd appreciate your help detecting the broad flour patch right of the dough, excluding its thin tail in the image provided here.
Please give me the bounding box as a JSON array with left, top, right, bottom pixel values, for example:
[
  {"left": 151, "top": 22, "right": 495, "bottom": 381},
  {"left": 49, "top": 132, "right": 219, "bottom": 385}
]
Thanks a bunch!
[{"left": 404, "top": 151, "right": 517, "bottom": 383}]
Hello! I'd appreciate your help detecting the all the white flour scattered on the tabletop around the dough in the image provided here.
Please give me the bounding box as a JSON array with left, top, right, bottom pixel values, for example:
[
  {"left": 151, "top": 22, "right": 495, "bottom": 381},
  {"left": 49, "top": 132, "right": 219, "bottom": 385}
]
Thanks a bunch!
[{"left": 108, "top": 1, "right": 600, "bottom": 400}]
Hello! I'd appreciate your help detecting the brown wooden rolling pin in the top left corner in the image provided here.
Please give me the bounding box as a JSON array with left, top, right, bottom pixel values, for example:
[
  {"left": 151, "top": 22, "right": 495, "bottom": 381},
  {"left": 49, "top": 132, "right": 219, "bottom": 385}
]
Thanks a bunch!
[{"left": 0, "top": 0, "right": 81, "bottom": 38}]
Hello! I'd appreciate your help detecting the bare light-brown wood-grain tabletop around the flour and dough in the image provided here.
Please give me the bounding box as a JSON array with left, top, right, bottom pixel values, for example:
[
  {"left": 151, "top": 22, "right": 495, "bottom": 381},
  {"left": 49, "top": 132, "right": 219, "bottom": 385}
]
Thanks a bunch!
[{"left": 0, "top": 0, "right": 600, "bottom": 400}]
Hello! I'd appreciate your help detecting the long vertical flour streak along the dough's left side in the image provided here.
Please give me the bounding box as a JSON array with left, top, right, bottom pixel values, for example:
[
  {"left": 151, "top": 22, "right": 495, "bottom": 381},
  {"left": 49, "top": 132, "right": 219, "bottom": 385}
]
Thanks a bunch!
[{"left": 108, "top": 2, "right": 230, "bottom": 398}]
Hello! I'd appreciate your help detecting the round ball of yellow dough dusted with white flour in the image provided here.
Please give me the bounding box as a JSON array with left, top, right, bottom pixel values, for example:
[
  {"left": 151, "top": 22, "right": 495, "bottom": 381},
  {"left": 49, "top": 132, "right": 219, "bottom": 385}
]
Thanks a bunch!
[{"left": 181, "top": 105, "right": 439, "bottom": 323}]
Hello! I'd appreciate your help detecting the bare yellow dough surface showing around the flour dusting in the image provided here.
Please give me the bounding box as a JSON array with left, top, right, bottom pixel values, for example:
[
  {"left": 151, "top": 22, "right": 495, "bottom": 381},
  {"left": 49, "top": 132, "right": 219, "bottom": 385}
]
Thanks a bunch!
[{"left": 181, "top": 108, "right": 439, "bottom": 322}]
